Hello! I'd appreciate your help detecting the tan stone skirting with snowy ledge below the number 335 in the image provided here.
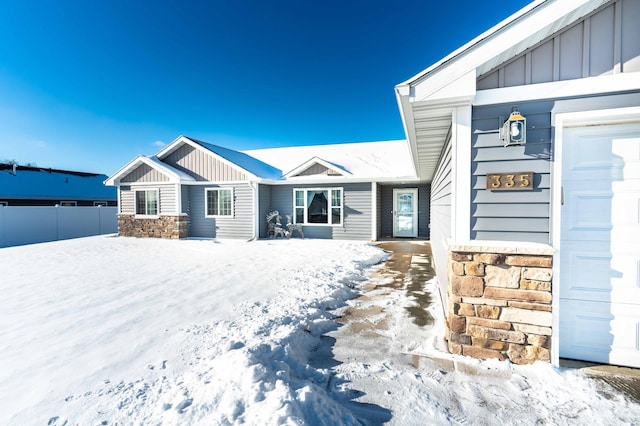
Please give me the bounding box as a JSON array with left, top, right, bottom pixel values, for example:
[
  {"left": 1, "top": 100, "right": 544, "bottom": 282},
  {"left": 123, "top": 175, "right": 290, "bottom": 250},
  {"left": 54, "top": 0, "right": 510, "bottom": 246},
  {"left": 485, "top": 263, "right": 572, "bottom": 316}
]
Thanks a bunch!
[{"left": 447, "top": 242, "right": 553, "bottom": 364}]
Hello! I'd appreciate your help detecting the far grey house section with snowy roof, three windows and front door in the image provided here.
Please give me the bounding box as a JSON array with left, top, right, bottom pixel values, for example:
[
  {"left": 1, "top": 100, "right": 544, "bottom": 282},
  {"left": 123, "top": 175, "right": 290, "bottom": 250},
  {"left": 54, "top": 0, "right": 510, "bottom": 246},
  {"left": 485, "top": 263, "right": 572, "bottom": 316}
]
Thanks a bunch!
[{"left": 105, "top": 136, "right": 429, "bottom": 240}]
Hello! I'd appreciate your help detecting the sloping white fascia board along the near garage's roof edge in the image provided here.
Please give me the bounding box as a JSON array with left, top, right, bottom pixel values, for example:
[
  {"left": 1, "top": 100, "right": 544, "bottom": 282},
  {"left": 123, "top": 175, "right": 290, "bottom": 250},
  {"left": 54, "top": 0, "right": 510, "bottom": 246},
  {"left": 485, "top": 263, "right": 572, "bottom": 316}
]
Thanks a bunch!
[{"left": 402, "top": 0, "right": 609, "bottom": 101}]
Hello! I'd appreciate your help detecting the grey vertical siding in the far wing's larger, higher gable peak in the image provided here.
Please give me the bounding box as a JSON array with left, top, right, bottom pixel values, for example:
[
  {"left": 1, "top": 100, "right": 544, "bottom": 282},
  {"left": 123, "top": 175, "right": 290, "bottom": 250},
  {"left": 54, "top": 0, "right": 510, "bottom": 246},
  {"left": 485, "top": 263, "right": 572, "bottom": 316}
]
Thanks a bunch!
[{"left": 162, "top": 144, "right": 249, "bottom": 182}]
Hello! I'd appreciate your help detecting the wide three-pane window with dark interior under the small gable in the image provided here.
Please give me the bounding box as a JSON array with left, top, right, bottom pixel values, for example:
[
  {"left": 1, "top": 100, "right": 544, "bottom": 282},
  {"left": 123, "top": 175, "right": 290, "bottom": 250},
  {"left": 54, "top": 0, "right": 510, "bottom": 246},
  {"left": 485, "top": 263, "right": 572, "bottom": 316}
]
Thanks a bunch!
[{"left": 293, "top": 188, "right": 342, "bottom": 225}]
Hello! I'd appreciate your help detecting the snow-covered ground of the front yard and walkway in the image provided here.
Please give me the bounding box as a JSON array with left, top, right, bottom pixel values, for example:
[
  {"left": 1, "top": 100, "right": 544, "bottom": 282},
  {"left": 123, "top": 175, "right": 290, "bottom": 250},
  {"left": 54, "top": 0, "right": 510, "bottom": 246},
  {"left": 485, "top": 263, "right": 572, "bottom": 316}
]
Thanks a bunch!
[{"left": 0, "top": 236, "right": 640, "bottom": 426}]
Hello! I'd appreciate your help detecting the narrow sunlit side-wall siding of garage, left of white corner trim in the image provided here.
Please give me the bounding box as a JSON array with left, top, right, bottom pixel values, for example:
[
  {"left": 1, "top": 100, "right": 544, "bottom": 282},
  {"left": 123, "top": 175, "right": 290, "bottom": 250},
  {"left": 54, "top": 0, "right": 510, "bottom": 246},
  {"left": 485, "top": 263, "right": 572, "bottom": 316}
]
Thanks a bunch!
[{"left": 429, "top": 132, "right": 452, "bottom": 306}]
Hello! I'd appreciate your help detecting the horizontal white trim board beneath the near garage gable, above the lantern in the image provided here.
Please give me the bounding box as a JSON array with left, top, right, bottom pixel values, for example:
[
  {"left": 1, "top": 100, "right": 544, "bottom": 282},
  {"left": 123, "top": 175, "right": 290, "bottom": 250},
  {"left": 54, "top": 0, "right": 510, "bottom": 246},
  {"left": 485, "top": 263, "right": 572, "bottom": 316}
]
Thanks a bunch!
[{"left": 473, "top": 72, "right": 640, "bottom": 106}]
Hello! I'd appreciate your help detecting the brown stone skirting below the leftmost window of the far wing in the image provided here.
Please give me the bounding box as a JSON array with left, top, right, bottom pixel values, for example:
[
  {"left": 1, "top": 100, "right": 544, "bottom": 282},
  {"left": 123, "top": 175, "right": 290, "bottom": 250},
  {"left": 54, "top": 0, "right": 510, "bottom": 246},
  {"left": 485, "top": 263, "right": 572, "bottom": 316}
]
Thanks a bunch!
[{"left": 118, "top": 214, "right": 189, "bottom": 239}]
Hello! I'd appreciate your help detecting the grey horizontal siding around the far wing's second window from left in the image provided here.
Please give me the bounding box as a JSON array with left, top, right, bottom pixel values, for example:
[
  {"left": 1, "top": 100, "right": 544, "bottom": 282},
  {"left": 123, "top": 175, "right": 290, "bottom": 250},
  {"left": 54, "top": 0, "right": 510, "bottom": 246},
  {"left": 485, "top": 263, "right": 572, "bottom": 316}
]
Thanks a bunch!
[{"left": 189, "top": 184, "right": 254, "bottom": 240}]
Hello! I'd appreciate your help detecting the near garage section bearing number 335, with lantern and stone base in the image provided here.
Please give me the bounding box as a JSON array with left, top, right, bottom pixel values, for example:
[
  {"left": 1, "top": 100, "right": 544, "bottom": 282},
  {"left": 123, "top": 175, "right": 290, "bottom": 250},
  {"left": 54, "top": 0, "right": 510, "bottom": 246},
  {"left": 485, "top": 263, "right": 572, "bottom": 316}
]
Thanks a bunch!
[{"left": 396, "top": 0, "right": 640, "bottom": 367}]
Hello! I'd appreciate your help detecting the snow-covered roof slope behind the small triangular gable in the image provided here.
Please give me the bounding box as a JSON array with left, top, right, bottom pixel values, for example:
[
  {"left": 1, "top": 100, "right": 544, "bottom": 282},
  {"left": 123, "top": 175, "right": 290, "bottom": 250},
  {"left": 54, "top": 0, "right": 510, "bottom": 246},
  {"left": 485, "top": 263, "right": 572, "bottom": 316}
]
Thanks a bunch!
[{"left": 244, "top": 140, "right": 416, "bottom": 181}]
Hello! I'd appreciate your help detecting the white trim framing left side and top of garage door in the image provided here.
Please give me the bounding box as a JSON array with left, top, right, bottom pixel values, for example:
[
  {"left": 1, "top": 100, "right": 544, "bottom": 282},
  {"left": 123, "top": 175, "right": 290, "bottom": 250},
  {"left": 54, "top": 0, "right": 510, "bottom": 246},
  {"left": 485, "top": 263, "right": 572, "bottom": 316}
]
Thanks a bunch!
[{"left": 550, "top": 105, "right": 640, "bottom": 366}]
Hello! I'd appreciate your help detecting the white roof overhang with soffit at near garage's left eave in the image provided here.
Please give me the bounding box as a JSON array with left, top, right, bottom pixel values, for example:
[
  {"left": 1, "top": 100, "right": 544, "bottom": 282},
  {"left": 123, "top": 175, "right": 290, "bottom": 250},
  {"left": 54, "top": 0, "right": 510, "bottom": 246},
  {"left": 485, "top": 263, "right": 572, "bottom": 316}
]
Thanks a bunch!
[{"left": 396, "top": 0, "right": 611, "bottom": 180}]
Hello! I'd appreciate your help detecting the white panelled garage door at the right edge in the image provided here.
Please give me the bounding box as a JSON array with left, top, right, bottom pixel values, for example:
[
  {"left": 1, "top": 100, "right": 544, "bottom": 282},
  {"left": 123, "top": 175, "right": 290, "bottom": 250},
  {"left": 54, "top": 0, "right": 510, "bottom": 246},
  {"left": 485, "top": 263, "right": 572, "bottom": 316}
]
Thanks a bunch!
[{"left": 559, "top": 123, "right": 640, "bottom": 367}]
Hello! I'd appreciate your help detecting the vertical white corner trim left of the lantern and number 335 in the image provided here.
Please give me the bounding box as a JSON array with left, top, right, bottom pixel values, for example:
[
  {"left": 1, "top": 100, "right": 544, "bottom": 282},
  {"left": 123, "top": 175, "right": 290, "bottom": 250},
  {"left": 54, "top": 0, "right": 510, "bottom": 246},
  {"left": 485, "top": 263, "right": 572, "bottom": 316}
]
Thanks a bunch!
[{"left": 451, "top": 105, "right": 471, "bottom": 241}]
